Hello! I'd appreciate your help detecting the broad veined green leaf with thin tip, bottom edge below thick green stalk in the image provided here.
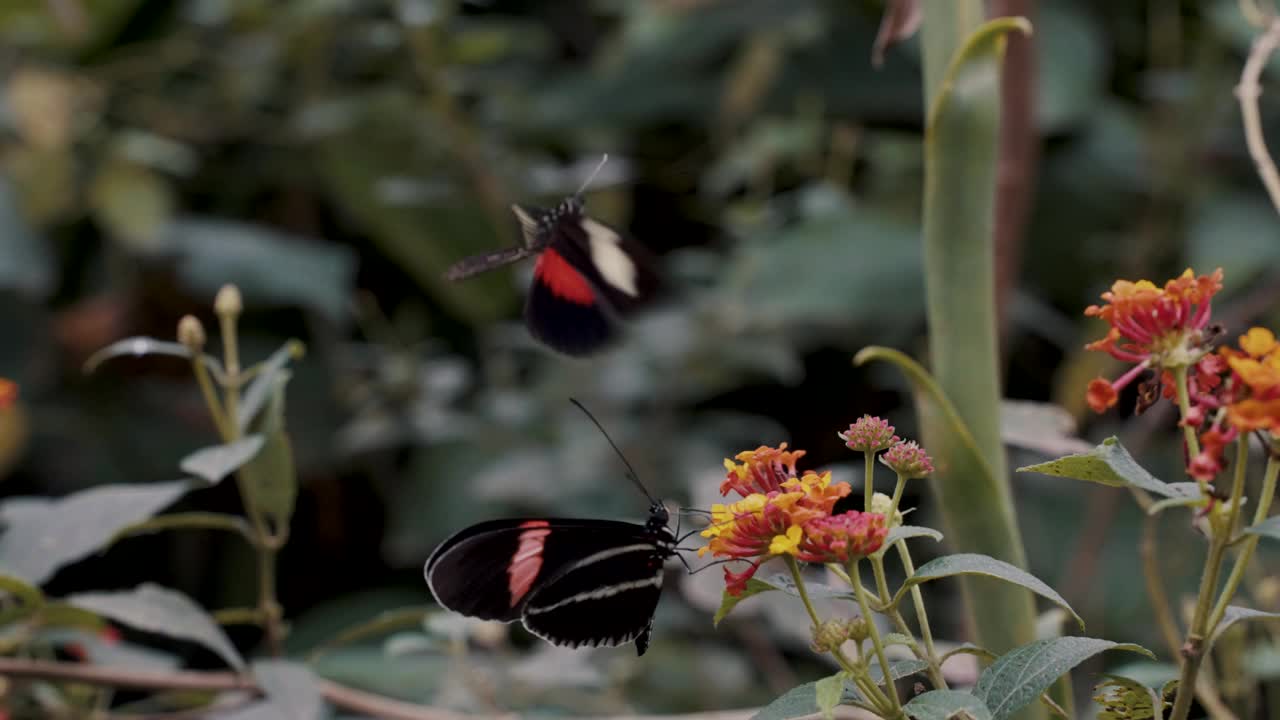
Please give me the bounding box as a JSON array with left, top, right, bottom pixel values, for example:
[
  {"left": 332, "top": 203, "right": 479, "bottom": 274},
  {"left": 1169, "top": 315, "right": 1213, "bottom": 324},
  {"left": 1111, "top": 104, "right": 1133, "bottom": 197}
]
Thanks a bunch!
[{"left": 973, "top": 638, "right": 1155, "bottom": 720}]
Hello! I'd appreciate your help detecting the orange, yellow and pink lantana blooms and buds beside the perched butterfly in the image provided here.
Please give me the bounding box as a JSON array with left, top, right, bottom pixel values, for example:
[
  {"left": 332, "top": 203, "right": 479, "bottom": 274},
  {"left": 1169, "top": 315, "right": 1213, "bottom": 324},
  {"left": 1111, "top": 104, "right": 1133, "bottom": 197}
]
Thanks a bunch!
[{"left": 699, "top": 416, "right": 933, "bottom": 596}]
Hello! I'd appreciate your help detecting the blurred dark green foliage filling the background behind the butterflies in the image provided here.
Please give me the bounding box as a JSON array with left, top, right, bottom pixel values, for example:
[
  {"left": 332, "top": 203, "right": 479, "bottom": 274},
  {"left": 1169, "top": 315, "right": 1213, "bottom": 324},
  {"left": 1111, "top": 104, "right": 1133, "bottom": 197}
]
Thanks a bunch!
[{"left": 0, "top": 0, "right": 1280, "bottom": 711}]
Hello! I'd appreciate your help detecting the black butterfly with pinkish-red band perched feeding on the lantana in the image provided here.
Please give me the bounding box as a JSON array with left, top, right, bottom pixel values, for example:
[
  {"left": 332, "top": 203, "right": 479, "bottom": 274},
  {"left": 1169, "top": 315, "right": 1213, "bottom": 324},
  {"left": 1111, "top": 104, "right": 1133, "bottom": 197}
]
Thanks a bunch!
[{"left": 424, "top": 401, "right": 676, "bottom": 655}]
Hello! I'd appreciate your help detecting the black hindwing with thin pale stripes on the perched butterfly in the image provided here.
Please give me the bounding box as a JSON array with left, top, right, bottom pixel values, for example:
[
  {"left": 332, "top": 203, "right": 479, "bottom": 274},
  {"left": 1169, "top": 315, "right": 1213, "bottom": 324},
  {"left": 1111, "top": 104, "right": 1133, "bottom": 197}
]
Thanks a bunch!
[{"left": 524, "top": 534, "right": 669, "bottom": 655}]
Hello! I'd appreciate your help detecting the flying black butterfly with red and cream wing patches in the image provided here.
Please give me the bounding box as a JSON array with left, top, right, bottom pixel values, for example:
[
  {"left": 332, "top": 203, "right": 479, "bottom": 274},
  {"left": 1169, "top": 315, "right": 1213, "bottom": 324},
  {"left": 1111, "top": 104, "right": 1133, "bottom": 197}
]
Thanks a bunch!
[{"left": 445, "top": 155, "right": 658, "bottom": 356}]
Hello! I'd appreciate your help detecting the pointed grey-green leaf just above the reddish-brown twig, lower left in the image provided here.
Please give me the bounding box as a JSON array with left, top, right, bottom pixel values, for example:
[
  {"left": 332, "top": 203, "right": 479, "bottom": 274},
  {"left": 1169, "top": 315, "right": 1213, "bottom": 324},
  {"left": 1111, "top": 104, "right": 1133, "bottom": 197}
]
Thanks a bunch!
[{"left": 65, "top": 583, "right": 244, "bottom": 670}]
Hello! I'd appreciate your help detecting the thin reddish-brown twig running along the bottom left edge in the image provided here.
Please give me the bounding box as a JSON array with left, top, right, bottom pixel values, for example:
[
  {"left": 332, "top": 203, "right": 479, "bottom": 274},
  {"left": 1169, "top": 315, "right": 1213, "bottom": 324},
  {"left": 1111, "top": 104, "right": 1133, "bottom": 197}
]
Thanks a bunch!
[{"left": 0, "top": 657, "right": 467, "bottom": 720}]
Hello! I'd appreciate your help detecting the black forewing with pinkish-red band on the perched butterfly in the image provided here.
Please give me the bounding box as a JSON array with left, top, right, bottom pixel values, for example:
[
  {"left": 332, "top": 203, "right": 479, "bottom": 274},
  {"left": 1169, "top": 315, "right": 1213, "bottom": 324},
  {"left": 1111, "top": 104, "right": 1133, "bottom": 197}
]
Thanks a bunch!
[{"left": 424, "top": 518, "right": 660, "bottom": 623}]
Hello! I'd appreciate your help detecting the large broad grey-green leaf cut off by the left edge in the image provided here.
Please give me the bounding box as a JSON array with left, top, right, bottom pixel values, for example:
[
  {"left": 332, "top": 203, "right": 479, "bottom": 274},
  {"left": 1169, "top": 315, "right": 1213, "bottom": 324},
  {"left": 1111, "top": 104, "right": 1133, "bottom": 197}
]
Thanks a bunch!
[{"left": 0, "top": 480, "right": 192, "bottom": 585}]
